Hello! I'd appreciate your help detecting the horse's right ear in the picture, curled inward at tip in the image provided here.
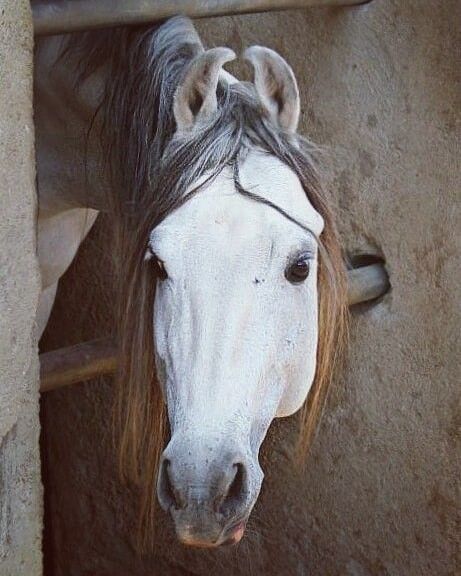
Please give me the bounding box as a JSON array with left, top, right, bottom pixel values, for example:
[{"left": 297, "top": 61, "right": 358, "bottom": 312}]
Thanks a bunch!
[{"left": 243, "top": 46, "right": 300, "bottom": 132}]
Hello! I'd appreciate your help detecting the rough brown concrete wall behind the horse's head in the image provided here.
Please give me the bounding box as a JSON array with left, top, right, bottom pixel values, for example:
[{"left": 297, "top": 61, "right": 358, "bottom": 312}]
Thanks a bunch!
[{"left": 43, "top": 0, "right": 461, "bottom": 576}]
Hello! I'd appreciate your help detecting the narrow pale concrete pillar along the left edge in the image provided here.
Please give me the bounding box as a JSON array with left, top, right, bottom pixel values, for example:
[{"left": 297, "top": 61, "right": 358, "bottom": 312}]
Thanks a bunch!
[{"left": 0, "top": 0, "right": 42, "bottom": 576}]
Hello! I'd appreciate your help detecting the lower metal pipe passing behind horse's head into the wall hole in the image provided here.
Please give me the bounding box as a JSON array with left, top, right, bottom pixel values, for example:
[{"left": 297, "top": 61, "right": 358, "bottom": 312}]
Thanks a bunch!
[{"left": 40, "top": 264, "right": 390, "bottom": 392}]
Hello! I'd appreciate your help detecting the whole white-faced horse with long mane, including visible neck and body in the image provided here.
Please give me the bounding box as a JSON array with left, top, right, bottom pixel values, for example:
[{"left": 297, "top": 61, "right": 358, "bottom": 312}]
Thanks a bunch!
[{"left": 35, "top": 17, "right": 347, "bottom": 548}]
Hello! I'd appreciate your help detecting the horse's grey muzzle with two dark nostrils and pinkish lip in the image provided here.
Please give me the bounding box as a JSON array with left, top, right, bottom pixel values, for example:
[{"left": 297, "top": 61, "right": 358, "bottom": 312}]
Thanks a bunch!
[{"left": 157, "top": 445, "right": 262, "bottom": 548}]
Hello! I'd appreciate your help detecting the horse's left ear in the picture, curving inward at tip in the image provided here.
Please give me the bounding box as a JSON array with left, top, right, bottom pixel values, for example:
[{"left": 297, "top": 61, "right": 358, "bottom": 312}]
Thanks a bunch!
[{"left": 173, "top": 48, "right": 235, "bottom": 131}]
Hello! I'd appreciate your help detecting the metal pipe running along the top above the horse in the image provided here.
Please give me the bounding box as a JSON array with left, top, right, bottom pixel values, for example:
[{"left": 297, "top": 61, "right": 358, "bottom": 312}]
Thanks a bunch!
[{"left": 32, "top": 0, "right": 367, "bottom": 36}]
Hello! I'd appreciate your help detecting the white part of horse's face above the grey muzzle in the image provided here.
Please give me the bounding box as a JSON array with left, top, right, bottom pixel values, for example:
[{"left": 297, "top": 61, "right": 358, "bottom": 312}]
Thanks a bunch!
[{"left": 150, "top": 151, "right": 323, "bottom": 432}]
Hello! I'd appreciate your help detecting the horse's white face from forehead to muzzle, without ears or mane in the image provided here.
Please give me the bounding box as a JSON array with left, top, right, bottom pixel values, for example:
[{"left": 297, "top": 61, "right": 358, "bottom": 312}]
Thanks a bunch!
[{"left": 150, "top": 151, "right": 323, "bottom": 545}]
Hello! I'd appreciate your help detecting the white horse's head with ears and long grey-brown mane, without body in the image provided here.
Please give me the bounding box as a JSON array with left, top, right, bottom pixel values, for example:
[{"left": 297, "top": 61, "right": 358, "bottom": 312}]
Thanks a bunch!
[{"left": 84, "top": 20, "right": 345, "bottom": 546}]
